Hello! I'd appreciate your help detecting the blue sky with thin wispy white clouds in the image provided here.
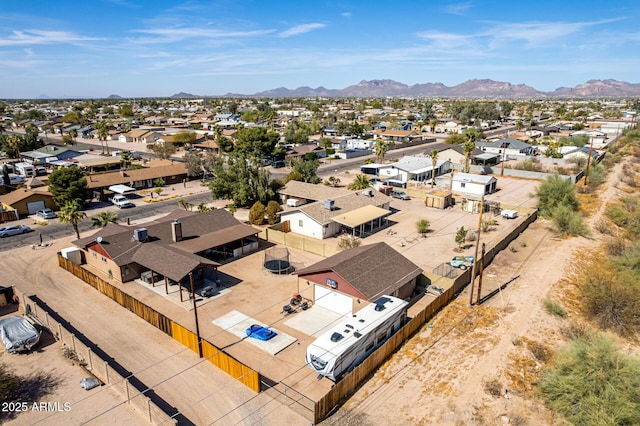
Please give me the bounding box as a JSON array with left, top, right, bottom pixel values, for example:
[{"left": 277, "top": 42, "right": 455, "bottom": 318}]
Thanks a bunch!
[{"left": 0, "top": 0, "right": 640, "bottom": 99}]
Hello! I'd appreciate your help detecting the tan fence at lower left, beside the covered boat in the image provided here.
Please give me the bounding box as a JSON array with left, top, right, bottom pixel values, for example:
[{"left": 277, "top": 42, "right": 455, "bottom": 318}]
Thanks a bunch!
[{"left": 14, "top": 287, "right": 177, "bottom": 425}]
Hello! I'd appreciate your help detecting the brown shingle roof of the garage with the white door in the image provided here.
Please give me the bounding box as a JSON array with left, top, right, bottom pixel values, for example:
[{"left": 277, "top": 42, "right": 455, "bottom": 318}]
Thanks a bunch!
[{"left": 296, "top": 242, "right": 422, "bottom": 300}]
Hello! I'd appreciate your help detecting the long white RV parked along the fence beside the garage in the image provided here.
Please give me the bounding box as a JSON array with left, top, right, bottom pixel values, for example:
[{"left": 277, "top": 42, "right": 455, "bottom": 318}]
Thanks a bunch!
[{"left": 306, "top": 296, "right": 408, "bottom": 381}]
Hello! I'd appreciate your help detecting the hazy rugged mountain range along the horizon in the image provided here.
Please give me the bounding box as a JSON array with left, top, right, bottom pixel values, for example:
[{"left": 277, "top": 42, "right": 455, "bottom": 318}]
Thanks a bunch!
[{"left": 198, "top": 79, "right": 640, "bottom": 99}]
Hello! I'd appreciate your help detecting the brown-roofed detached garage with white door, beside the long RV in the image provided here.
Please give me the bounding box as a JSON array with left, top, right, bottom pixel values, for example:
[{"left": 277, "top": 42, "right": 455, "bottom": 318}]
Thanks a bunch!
[{"left": 296, "top": 242, "right": 422, "bottom": 314}]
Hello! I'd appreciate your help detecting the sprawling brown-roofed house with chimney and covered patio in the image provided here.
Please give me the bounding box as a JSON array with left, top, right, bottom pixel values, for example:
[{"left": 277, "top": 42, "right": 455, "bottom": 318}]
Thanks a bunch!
[{"left": 73, "top": 209, "right": 258, "bottom": 292}]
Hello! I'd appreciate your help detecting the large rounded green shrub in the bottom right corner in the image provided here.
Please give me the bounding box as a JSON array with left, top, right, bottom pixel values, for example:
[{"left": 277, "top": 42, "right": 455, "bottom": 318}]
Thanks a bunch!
[{"left": 538, "top": 333, "right": 640, "bottom": 425}]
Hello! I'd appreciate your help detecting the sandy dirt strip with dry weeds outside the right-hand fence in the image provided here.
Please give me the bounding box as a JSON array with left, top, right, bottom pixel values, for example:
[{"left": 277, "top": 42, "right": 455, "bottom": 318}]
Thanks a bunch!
[{"left": 324, "top": 159, "right": 619, "bottom": 425}]
